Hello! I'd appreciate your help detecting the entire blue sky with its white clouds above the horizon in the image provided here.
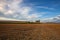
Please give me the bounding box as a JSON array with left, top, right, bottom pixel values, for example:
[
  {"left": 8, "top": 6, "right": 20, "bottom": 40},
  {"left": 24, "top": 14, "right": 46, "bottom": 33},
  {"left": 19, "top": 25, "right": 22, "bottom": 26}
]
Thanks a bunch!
[{"left": 0, "top": 0, "right": 60, "bottom": 22}]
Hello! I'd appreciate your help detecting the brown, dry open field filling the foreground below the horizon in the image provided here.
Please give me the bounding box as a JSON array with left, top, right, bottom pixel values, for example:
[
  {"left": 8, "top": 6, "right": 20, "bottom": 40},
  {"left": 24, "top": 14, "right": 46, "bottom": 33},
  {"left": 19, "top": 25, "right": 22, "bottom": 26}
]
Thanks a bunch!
[{"left": 0, "top": 24, "right": 60, "bottom": 40}]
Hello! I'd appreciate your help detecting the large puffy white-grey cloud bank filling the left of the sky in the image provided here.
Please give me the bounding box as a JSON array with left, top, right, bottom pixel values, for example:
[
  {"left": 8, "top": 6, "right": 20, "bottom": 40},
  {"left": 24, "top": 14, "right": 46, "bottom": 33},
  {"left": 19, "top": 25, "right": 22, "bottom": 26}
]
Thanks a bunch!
[{"left": 0, "top": 0, "right": 39, "bottom": 20}]
